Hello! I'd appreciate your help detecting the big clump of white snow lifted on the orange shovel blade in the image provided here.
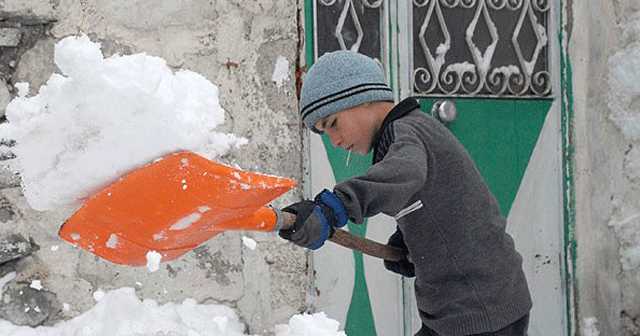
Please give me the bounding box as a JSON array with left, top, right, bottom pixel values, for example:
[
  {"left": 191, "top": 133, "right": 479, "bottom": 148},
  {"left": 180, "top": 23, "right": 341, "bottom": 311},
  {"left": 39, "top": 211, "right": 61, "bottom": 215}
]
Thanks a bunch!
[{"left": 0, "top": 36, "right": 247, "bottom": 210}]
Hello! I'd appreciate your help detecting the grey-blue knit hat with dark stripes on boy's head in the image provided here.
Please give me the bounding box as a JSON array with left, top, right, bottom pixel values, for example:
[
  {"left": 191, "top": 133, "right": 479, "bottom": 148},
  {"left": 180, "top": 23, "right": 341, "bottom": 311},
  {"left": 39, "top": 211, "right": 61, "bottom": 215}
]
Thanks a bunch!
[{"left": 300, "top": 50, "right": 393, "bottom": 133}]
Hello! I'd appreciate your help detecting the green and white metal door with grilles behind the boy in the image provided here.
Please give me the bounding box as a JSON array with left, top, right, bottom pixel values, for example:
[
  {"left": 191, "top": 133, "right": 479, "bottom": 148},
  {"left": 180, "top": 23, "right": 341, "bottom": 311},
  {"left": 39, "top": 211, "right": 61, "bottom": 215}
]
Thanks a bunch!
[{"left": 305, "top": 0, "right": 566, "bottom": 336}]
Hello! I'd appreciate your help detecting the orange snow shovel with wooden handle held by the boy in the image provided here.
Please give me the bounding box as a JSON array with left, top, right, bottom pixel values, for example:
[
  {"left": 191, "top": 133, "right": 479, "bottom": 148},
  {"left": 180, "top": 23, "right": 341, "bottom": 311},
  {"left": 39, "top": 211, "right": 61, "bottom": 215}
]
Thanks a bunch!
[{"left": 58, "top": 151, "right": 404, "bottom": 266}]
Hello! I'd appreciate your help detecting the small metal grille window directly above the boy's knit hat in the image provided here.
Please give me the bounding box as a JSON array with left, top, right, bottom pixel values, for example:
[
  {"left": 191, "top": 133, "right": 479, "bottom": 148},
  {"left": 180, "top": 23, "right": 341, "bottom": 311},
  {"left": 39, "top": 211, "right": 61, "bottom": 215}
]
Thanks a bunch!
[{"left": 313, "top": 0, "right": 387, "bottom": 61}]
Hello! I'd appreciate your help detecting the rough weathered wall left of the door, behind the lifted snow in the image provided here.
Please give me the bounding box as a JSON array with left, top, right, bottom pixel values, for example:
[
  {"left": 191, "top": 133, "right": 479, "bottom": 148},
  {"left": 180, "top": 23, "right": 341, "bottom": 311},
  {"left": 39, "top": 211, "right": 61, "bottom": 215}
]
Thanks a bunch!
[{"left": 0, "top": 0, "right": 308, "bottom": 334}]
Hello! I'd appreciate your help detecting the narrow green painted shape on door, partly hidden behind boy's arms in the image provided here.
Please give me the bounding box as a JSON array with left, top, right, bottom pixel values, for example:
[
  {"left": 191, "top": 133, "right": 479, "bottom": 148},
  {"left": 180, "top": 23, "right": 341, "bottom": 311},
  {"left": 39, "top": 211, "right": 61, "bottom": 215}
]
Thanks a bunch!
[{"left": 322, "top": 135, "right": 376, "bottom": 336}]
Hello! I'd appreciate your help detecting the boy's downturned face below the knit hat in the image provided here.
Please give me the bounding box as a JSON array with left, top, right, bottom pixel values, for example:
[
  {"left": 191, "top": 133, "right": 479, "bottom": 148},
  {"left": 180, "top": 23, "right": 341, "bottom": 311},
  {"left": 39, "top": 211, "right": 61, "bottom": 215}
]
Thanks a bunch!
[{"left": 315, "top": 104, "right": 379, "bottom": 155}]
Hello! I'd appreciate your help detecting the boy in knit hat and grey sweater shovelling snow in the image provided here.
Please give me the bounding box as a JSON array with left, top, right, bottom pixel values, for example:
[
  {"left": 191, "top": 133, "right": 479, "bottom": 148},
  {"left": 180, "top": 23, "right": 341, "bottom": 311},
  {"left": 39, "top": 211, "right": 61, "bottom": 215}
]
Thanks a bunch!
[{"left": 280, "top": 51, "right": 531, "bottom": 336}]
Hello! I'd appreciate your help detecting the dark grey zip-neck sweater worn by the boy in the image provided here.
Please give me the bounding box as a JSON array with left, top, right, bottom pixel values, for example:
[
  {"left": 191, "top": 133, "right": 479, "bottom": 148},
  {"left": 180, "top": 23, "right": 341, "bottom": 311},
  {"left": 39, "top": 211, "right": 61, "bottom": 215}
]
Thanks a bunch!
[{"left": 334, "top": 99, "right": 531, "bottom": 336}]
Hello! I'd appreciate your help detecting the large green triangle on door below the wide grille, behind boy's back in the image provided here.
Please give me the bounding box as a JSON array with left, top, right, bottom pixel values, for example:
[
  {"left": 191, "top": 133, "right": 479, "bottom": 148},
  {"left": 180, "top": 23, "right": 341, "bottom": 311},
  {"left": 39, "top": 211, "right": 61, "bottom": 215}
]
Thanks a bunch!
[{"left": 420, "top": 99, "right": 552, "bottom": 216}]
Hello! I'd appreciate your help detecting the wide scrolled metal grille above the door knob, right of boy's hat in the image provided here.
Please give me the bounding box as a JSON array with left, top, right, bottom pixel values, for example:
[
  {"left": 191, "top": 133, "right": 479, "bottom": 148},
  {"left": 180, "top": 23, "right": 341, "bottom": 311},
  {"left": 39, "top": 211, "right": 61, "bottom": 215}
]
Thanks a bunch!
[{"left": 412, "top": 0, "right": 551, "bottom": 98}]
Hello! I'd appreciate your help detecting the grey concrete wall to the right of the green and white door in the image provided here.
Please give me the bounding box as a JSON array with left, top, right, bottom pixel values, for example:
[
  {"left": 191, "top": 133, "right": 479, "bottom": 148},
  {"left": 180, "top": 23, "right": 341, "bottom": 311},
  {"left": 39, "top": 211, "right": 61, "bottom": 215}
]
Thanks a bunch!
[{"left": 564, "top": 0, "right": 640, "bottom": 336}]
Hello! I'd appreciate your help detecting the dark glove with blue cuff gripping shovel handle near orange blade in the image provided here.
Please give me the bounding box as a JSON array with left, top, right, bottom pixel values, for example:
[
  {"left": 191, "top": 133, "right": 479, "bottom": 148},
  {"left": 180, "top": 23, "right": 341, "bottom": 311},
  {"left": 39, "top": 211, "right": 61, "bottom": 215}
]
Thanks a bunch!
[{"left": 278, "top": 200, "right": 334, "bottom": 250}]
